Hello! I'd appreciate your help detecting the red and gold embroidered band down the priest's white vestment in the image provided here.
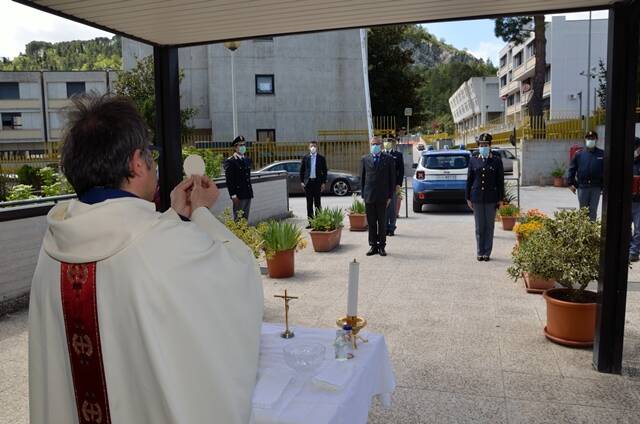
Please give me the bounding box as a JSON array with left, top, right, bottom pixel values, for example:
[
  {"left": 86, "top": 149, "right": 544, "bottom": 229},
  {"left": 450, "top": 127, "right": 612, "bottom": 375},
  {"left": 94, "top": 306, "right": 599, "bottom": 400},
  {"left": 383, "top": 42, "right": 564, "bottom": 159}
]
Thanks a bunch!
[{"left": 60, "top": 262, "right": 111, "bottom": 424}]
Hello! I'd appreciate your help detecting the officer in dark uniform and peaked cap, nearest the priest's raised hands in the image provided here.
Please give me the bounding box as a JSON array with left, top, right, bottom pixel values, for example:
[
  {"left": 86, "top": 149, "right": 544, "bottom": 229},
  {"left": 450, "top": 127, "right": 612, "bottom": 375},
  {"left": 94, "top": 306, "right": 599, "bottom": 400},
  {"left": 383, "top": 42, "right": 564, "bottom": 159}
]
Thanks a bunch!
[{"left": 224, "top": 135, "right": 253, "bottom": 220}]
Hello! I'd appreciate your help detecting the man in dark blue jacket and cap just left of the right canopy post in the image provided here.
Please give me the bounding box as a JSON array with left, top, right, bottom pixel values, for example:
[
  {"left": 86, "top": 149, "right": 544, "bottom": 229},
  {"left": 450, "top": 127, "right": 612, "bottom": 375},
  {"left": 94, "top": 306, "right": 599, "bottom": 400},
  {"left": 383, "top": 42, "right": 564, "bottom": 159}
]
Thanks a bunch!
[{"left": 567, "top": 131, "right": 604, "bottom": 221}]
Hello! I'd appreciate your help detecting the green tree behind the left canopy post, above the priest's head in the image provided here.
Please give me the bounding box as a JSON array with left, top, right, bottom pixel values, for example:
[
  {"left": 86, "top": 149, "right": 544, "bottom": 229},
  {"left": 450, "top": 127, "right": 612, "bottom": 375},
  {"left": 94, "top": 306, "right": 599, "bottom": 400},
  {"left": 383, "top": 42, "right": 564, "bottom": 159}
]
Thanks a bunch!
[{"left": 114, "top": 56, "right": 197, "bottom": 135}]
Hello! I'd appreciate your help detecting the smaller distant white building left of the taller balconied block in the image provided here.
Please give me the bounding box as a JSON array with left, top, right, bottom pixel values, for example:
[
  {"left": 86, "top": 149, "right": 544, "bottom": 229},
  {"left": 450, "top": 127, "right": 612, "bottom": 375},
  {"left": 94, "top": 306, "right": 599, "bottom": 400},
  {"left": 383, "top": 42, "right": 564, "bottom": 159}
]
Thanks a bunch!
[{"left": 449, "top": 77, "right": 504, "bottom": 133}]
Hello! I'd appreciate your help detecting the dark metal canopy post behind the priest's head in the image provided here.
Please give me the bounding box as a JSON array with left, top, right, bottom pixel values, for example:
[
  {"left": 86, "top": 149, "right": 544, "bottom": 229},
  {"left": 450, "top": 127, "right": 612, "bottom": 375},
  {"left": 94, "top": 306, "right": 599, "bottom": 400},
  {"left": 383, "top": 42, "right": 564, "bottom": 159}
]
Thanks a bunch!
[{"left": 153, "top": 46, "right": 182, "bottom": 211}]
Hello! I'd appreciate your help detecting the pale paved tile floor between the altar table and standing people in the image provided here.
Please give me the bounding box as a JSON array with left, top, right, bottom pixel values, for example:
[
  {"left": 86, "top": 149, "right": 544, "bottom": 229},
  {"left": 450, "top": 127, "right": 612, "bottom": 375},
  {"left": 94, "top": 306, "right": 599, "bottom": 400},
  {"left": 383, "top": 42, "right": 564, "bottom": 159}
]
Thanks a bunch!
[{"left": 0, "top": 188, "right": 640, "bottom": 424}]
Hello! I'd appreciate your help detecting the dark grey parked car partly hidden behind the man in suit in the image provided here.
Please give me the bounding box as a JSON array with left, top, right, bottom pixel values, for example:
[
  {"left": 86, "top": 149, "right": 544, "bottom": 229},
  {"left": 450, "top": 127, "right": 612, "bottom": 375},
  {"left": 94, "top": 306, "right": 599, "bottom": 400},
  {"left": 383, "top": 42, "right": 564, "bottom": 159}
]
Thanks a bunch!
[{"left": 258, "top": 160, "right": 360, "bottom": 196}]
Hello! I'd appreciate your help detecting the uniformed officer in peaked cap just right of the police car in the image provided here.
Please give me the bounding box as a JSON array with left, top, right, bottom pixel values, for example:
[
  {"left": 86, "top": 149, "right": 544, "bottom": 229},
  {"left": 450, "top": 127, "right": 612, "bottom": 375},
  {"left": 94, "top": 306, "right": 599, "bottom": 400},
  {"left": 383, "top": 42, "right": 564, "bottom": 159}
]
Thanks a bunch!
[{"left": 466, "top": 133, "right": 504, "bottom": 261}]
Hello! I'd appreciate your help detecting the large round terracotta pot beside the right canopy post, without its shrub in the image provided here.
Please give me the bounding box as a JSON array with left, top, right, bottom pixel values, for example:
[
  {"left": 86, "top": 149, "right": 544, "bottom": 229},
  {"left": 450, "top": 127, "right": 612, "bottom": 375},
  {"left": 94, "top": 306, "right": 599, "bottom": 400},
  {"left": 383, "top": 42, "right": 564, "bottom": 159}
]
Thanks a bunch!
[{"left": 543, "top": 289, "right": 596, "bottom": 347}]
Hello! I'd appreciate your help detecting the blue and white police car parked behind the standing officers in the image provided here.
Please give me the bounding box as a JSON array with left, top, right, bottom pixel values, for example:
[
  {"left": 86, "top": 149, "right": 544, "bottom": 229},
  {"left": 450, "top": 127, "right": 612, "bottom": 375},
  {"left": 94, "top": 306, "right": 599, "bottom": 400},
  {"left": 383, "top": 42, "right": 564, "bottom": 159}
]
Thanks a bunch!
[{"left": 413, "top": 149, "right": 471, "bottom": 212}]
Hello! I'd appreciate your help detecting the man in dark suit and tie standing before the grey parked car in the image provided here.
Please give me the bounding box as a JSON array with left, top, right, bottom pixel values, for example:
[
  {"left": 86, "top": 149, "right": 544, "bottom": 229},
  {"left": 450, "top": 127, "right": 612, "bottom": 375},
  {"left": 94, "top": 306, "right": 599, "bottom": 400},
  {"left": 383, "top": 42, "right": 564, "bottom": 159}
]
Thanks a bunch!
[{"left": 300, "top": 140, "right": 327, "bottom": 228}]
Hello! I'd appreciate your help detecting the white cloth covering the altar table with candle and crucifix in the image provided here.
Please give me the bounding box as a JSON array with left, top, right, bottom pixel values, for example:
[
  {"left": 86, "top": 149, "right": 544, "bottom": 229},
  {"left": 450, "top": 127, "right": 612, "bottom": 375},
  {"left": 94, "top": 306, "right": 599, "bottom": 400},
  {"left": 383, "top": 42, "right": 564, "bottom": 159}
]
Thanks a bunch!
[{"left": 253, "top": 323, "right": 395, "bottom": 424}]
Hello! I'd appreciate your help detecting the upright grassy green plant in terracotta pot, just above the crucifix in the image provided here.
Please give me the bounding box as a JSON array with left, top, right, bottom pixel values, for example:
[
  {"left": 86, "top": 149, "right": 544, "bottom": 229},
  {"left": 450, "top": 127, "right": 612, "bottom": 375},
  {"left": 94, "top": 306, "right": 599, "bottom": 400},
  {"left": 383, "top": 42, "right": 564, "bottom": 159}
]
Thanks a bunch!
[{"left": 260, "top": 221, "right": 306, "bottom": 278}]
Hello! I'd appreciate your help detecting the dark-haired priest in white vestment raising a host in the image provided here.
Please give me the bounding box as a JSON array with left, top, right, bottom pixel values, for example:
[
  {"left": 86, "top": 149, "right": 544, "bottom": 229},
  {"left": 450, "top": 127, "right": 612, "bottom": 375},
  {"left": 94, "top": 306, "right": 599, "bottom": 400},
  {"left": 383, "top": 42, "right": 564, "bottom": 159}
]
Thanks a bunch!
[{"left": 29, "top": 96, "right": 263, "bottom": 424}]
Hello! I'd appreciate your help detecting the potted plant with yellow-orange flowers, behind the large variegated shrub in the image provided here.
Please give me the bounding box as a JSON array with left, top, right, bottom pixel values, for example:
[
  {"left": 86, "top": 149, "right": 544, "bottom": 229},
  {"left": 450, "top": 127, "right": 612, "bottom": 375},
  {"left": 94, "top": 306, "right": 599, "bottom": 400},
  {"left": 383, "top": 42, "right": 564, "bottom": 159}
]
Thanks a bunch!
[{"left": 507, "top": 220, "right": 556, "bottom": 293}]
